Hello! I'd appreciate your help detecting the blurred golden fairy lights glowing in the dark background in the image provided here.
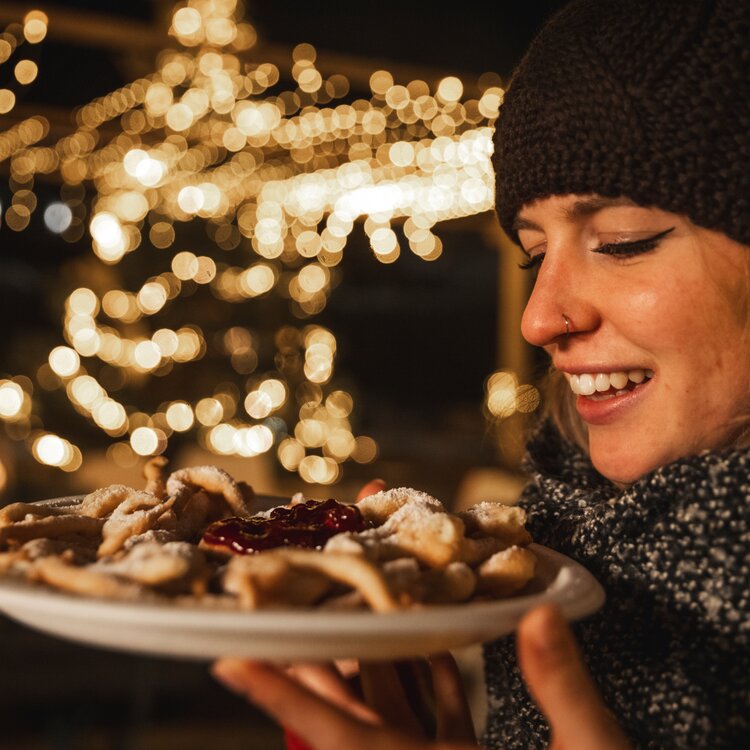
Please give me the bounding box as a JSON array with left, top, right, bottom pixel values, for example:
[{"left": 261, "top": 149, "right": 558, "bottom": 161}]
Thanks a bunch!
[{"left": 0, "top": 0, "right": 536, "bottom": 484}]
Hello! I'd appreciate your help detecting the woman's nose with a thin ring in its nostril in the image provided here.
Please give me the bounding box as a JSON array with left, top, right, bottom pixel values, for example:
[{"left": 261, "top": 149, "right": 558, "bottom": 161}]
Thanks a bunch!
[{"left": 521, "top": 251, "right": 599, "bottom": 346}]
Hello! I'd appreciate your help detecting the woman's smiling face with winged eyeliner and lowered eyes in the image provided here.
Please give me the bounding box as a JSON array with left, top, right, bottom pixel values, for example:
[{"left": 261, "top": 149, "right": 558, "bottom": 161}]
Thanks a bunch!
[{"left": 517, "top": 195, "right": 750, "bottom": 483}]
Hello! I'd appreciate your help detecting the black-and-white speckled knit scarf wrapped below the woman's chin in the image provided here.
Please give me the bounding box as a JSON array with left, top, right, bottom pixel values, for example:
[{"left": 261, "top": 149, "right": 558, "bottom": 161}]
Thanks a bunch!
[{"left": 485, "top": 425, "right": 750, "bottom": 750}]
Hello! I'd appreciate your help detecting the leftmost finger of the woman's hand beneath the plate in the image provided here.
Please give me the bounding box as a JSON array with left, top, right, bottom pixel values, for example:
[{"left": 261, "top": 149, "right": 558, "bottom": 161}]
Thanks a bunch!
[{"left": 212, "top": 659, "right": 394, "bottom": 750}]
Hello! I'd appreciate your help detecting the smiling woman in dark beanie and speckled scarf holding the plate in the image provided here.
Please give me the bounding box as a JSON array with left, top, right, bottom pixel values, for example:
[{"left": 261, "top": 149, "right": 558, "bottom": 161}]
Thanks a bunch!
[{"left": 215, "top": 0, "right": 750, "bottom": 750}]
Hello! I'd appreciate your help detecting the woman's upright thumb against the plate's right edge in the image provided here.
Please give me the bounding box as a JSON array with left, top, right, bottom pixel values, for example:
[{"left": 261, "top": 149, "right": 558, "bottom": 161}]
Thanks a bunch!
[{"left": 518, "top": 605, "right": 628, "bottom": 750}]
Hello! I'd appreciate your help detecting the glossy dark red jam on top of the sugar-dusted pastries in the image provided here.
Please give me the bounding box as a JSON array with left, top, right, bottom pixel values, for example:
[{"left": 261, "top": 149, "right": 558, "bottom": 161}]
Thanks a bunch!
[{"left": 203, "top": 500, "right": 366, "bottom": 555}]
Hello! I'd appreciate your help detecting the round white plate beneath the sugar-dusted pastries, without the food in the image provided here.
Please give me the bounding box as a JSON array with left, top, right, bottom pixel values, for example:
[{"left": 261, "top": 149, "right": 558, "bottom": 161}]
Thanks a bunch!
[{"left": 0, "top": 498, "right": 604, "bottom": 661}]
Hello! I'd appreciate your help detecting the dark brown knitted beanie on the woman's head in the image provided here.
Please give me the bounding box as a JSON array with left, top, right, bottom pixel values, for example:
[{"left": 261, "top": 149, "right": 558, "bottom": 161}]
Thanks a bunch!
[{"left": 494, "top": 0, "right": 750, "bottom": 245}]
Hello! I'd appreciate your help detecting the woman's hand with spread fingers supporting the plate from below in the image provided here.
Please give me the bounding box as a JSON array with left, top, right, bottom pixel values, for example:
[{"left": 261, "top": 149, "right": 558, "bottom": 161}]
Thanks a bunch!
[{"left": 213, "top": 605, "right": 629, "bottom": 750}]
